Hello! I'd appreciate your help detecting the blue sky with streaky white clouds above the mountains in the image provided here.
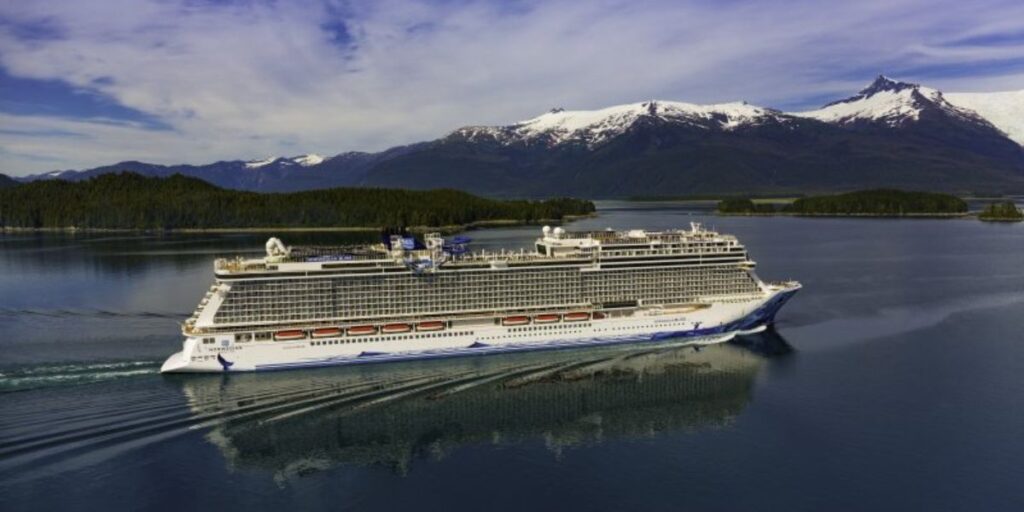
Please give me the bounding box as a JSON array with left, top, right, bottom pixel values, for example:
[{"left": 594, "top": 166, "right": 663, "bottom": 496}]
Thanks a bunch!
[{"left": 0, "top": 0, "right": 1024, "bottom": 175}]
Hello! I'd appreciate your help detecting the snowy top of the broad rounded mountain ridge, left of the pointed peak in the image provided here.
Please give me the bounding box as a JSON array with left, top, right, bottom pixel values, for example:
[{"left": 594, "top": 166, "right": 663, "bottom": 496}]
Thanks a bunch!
[{"left": 450, "top": 100, "right": 791, "bottom": 146}]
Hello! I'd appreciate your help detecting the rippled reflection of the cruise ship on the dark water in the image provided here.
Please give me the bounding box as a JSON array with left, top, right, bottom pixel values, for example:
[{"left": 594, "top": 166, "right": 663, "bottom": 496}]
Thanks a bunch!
[{"left": 180, "top": 331, "right": 790, "bottom": 482}]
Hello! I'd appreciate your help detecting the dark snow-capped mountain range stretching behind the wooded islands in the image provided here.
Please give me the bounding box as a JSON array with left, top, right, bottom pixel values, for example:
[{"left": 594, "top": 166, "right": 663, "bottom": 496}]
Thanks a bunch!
[{"left": 9, "top": 77, "right": 1024, "bottom": 198}]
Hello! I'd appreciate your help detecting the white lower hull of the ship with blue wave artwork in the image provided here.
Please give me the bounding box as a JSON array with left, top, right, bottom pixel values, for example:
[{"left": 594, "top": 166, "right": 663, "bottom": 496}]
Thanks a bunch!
[{"left": 161, "top": 285, "right": 800, "bottom": 373}]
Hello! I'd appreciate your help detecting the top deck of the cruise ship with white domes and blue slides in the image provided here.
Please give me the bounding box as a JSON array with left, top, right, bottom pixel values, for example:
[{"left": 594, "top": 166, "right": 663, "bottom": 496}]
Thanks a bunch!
[{"left": 214, "top": 223, "right": 753, "bottom": 279}]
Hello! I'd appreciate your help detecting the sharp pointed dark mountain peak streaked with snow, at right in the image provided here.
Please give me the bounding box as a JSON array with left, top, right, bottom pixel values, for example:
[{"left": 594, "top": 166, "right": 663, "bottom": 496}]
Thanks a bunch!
[{"left": 793, "top": 76, "right": 982, "bottom": 127}]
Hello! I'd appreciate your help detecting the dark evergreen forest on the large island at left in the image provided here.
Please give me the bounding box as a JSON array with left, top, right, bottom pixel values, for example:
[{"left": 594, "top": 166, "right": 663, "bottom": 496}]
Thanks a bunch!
[{"left": 0, "top": 172, "right": 595, "bottom": 229}]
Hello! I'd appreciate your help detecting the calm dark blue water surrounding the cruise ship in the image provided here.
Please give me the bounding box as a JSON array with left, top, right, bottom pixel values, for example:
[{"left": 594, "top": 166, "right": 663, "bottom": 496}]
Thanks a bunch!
[{"left": 0, "top": 203, "right": 1024, "bottom": 510}]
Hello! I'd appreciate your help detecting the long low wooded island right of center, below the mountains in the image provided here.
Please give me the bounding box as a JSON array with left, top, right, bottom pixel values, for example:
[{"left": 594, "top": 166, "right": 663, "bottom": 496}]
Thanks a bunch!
[{"left": 718, "top": 189, "right": 967, "bottom": 216}]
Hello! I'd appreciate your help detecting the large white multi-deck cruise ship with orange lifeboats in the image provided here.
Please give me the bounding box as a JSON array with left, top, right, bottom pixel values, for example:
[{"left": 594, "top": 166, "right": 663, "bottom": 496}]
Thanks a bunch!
[{"left": 161, "top": 223, "right": 801, "bottom": 373}]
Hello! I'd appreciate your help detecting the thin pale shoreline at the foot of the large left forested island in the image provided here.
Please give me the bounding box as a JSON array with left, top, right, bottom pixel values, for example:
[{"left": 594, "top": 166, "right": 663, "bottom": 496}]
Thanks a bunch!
[{"left": 0, "top": 213, "right": 597, "bottom": 234}]
